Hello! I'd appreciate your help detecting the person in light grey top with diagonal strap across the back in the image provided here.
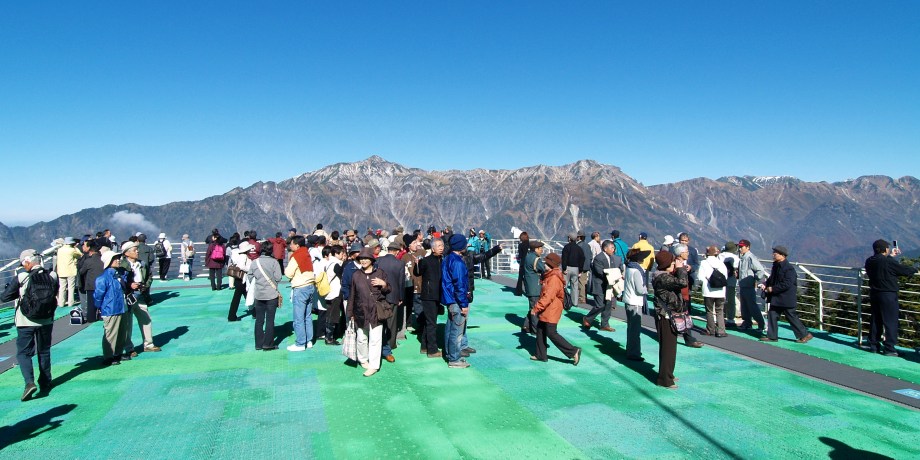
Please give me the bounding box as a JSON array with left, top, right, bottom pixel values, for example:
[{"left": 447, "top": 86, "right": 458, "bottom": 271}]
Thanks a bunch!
[{"left": 248, "top": 242, "right": 281, "bottom": 351}]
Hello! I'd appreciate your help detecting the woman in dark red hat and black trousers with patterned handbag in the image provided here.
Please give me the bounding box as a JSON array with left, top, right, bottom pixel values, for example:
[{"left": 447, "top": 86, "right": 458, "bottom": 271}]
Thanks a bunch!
[{"left": 652, "top": 251, "right": 687, "bottom": 390}]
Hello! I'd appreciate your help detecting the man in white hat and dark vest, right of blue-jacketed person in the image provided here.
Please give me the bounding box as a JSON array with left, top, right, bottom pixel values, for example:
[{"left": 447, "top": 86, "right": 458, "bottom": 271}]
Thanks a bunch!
[{"left": 121, "top": 241, "right": 160, "bottom": 360}]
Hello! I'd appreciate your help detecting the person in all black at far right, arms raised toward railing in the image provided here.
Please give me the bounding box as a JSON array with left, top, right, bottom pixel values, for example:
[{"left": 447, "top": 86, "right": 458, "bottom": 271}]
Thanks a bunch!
[{"left": 863, "top": 239, "right": 917, "bottom": 356}]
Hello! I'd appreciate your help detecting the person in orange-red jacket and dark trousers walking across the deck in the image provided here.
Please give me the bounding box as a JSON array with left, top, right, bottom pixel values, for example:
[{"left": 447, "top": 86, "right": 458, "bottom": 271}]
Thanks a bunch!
[{"left": 530, "top": 253, "right": 581, "bottom": 366}]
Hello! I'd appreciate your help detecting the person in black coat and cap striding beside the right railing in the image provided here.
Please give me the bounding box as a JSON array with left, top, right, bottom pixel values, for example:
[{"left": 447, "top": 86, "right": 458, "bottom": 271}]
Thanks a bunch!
[{"left": 760, "top": 246, "right": 813, "bottom": 343}]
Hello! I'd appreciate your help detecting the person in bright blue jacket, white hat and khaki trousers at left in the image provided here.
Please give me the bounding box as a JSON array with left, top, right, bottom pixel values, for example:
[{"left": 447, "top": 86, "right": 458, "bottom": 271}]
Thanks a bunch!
[{"left": 93, "top": 251, "right": 138, "bottom": 366}]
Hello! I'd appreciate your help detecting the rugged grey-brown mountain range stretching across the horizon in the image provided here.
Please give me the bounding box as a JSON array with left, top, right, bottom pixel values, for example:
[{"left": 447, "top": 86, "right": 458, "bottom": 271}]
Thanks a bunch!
[{"left": 0, "top": 156, "right": 920, "bottom": 265}]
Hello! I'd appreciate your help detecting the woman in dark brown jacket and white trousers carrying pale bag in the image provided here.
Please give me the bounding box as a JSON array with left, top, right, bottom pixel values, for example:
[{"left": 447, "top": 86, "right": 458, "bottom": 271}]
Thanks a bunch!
[{"left": 348, "top": 247, "right": 390, "bottom": 377}]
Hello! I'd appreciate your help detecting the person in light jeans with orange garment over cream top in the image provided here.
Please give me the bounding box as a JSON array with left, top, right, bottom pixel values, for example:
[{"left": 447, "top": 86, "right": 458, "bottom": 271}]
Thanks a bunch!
[{"left": 284, "top": 235, "right": 316, "bottom": 351}]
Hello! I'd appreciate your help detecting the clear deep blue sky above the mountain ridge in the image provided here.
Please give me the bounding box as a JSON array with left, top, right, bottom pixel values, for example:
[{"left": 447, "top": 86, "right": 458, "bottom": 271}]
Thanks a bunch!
[{"left": 0, "top": 0, "right": 920, "bottom": 225}]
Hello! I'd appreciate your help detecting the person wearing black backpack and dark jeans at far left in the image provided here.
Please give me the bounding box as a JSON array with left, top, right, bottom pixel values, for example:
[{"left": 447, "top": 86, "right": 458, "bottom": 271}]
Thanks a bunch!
[{"left": 0, "top": 249, "right": 59, "bottom": 401}]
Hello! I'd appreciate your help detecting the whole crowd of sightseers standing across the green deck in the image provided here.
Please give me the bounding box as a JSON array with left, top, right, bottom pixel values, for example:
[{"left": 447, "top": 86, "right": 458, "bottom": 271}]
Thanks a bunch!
[{"left": 3, "top": 224, "right": 917, "bottom": 400}]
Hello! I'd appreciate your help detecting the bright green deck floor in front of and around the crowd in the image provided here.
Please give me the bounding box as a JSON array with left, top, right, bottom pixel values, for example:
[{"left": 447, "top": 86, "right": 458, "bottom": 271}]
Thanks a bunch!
[{"left": 0, "top": 280, "right": 920, "bottom": 459}]
